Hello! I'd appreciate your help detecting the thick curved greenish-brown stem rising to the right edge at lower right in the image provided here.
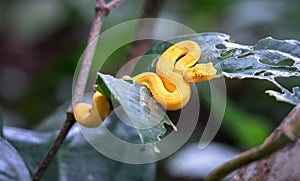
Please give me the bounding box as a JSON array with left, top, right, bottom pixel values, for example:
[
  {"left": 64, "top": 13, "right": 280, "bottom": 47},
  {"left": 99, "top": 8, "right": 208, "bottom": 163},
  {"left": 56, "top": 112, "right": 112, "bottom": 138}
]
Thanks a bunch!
[{"left": 206, "top": 104, "right": 300, "bottom": 181}]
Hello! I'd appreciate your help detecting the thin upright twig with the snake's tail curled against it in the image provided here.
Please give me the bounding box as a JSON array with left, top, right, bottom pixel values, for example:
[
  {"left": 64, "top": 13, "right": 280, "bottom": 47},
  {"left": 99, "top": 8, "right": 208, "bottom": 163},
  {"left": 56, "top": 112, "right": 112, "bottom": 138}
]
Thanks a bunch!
[{"left": 32, "top": 0, "right": 122, "bottom": 181}]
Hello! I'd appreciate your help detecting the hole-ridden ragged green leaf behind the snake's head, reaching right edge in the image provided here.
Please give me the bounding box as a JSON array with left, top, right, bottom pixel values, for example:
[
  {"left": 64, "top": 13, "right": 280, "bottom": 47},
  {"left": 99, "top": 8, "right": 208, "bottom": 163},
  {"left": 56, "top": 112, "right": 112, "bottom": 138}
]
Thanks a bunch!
[{"left": 133, "top": 33, "right": 300, "bottom": 105}]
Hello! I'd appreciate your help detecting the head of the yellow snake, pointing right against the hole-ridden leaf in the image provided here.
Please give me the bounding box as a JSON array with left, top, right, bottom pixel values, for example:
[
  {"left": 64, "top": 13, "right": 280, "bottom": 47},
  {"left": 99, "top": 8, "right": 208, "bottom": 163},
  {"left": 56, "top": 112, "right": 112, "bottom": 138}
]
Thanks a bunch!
[{"left": 183, "top": 62, "right": 217, "bottom": 82}]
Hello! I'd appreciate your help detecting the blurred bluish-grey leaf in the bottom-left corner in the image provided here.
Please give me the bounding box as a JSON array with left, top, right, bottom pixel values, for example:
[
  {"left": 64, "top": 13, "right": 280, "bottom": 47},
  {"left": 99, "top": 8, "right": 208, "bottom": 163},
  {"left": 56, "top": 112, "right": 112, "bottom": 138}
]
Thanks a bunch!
[{"left": 0, "top": 137, "right": 31, "bottom": 181}]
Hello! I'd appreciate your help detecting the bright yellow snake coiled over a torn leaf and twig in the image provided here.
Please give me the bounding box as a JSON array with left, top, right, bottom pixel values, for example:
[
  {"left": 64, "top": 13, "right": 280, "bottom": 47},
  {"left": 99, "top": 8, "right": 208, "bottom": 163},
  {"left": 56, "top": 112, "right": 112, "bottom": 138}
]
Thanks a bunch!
[{"left": 74, "top": 40, "right": 217, "bottom": 127}]
